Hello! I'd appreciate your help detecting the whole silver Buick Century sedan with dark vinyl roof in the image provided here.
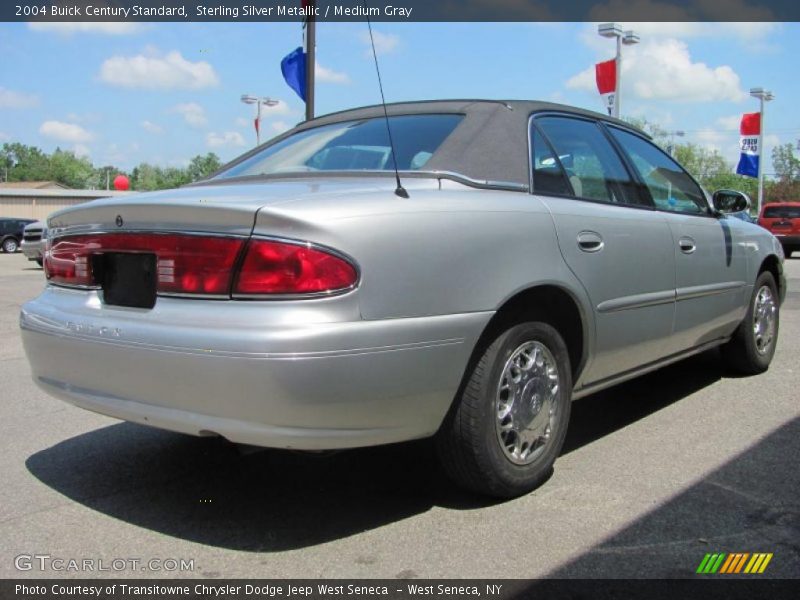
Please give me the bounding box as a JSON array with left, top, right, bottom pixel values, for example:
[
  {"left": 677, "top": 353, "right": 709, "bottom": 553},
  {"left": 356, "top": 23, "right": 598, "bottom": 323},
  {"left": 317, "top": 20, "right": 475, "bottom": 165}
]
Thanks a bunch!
[{"left": 20, "top": 100, "right": 786, "bottom": 497}]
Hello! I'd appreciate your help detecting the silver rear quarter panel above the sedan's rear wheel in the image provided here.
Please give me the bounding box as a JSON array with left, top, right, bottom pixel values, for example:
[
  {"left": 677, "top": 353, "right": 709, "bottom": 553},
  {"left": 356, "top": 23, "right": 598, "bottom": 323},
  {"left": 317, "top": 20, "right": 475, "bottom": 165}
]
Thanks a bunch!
[{"left": 254, "top": 182, "right": 594, "bottom": 364}]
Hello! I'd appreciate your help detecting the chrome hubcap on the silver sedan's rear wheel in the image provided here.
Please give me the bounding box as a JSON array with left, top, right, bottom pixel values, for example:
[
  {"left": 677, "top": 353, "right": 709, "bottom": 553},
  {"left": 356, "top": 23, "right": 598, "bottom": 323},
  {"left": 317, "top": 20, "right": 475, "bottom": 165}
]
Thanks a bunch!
[{"left": 495, "top": 342, "right": 559, "bottom": 465}]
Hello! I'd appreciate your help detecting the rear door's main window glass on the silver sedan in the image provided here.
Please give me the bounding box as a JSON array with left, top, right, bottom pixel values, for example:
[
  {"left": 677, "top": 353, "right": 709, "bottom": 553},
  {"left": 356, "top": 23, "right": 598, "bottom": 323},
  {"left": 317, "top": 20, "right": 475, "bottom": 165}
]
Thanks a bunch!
[{"left": 535, "top": 117, "right": 645, "bottom": 204}]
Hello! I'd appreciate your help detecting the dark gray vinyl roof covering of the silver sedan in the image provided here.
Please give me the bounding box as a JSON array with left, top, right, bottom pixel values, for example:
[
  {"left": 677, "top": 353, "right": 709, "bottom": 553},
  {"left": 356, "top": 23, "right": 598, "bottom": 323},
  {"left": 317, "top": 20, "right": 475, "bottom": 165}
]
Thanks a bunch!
[{"left": 291, "top": 100, "right": 644, "bottom": 186}]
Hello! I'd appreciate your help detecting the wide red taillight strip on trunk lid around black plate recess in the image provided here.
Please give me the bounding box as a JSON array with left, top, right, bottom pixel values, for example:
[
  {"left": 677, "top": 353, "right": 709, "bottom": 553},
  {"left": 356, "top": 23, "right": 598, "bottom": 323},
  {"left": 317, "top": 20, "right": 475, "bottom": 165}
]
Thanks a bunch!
[{"left": 45, "top": 233, "right": 244, "bottom": 295}]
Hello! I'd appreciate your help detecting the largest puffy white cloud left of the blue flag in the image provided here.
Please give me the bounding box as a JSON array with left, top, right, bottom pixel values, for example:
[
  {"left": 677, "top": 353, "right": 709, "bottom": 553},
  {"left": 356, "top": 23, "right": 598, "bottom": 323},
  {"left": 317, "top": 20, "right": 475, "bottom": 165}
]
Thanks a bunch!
[{"left": 100, "top": 49, "right": 219, "bottom": 90}]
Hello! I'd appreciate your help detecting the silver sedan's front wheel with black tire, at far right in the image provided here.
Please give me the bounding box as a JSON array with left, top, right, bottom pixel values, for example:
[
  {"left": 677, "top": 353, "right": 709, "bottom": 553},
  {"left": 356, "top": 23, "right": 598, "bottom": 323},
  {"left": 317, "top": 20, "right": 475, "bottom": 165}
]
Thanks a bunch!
[{"left": 722, "top": 271, "right": 780, "bottom": 375}]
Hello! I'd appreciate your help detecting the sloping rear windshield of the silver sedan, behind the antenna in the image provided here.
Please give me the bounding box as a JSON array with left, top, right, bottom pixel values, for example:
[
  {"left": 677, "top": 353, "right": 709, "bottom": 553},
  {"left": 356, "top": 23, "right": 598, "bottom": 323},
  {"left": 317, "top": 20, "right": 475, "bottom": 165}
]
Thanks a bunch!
[{"left": 215, "top": 114, "right": 464, "bottom": 179}]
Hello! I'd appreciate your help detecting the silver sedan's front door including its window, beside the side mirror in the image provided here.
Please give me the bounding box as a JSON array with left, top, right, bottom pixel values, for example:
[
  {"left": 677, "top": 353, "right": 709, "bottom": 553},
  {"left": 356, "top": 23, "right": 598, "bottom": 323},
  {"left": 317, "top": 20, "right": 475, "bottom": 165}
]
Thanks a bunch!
[{"left": 609, "top": 126, "right": 750, "bottom": 352}]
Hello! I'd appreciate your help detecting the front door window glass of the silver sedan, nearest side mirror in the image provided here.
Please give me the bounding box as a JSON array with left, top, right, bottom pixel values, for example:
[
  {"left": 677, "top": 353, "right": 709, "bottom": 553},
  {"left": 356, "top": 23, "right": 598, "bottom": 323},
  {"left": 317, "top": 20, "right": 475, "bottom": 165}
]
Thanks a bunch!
[{"left": 610, "top": 127, "right": 708, "bottom": 214}]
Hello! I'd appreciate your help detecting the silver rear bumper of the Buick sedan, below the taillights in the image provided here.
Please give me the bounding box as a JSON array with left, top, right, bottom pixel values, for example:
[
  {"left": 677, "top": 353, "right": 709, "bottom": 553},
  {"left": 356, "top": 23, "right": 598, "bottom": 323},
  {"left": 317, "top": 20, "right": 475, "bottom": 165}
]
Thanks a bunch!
[{"left": 20, "top": 287, "right": 492, "bottom": 450}]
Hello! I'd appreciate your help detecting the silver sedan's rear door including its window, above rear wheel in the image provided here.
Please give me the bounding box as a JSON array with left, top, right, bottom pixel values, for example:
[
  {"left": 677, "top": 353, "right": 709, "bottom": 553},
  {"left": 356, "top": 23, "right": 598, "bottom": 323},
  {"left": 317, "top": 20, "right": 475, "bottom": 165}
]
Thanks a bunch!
[{"left": 531, "top": 115, "right": 675, "bottom": 384}]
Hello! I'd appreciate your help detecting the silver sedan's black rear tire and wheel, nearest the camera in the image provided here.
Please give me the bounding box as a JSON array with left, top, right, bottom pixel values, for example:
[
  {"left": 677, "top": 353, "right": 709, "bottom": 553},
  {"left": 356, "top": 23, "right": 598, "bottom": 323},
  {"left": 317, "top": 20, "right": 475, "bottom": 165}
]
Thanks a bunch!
[{"left": 436, "top": 322, "right": 572, "bottom": 498}]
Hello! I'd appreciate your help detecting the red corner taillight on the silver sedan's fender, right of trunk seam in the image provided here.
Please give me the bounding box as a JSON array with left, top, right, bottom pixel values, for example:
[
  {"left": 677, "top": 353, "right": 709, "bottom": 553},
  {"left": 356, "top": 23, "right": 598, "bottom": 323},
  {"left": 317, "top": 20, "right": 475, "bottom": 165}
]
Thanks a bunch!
[{"left": 234, "top": 239, "right": 358, "bottom": 295}]
